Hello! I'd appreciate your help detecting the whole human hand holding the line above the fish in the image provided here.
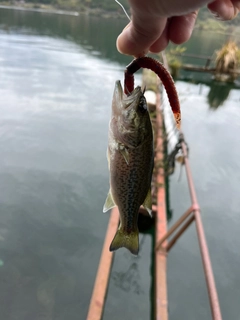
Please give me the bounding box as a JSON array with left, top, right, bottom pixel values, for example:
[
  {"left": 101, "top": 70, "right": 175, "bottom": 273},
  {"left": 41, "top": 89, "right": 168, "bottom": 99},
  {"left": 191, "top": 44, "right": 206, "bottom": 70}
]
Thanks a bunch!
[{"left": 117, "top": 0, "right": 240, "bottom": 57}]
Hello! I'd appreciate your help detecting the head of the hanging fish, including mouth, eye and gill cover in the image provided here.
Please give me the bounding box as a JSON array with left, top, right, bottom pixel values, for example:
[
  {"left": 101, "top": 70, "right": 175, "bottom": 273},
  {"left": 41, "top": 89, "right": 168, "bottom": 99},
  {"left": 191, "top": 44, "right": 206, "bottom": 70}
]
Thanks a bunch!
[{"left": 112, "top": 81, "right": 151, "bottom": 143}]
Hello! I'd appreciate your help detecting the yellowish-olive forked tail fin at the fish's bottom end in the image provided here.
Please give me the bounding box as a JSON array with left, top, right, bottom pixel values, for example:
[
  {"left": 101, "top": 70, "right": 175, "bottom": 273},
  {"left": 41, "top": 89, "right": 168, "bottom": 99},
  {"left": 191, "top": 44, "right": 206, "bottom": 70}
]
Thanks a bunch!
[{"left": 109, "top": 228, "right": 139, "bottom": 255}]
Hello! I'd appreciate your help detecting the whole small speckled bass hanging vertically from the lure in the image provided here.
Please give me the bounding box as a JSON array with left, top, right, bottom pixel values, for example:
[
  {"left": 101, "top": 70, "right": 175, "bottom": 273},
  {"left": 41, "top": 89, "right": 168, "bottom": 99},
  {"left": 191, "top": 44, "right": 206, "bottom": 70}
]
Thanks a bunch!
[{"left": 103, "top": 81, "right": 154, "bottom": 255}]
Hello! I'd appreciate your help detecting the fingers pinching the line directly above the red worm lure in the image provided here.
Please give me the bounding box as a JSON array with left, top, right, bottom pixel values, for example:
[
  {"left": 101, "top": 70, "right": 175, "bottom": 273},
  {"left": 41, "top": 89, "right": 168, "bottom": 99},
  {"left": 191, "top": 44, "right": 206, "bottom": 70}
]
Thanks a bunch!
[{"left": 117, "top": 0, "right": 201, "bottom": 57}]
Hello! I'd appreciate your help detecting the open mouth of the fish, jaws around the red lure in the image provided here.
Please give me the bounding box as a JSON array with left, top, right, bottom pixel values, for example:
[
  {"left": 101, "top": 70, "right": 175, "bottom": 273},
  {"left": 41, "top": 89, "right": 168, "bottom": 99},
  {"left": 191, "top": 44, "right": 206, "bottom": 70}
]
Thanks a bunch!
[{"left": 114, "top": 80, "right": 144, "bottom": 111}]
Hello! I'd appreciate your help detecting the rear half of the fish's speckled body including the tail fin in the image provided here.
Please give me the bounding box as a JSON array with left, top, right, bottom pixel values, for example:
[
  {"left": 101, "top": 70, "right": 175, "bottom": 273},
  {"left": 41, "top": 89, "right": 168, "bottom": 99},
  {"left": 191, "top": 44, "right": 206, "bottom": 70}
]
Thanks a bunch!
[{"left": 110, "top": 142, "right": 153, "bottom": 254}]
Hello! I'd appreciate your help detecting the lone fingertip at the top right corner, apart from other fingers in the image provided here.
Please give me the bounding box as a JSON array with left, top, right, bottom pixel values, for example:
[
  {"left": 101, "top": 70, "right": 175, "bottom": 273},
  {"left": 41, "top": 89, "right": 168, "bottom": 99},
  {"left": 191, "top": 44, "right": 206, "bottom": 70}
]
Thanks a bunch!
[{"left": 208, "top": 0, "right": 240, "bottom": 20}]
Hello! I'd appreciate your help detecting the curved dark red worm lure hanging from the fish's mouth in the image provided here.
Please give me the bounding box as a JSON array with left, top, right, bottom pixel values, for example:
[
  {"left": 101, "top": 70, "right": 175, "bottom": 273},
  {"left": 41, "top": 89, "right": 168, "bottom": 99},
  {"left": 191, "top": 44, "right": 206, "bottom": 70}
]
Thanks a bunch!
[{"left": 124, "top": 57, "right": 181, "bottom": 129}]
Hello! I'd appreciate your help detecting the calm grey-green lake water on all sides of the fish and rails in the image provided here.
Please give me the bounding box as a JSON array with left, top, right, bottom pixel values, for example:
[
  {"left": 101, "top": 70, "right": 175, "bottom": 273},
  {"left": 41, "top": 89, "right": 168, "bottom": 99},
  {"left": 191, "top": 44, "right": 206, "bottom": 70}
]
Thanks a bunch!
[{"left": 0, "top": 6, "right": 240, "bottom": 320}]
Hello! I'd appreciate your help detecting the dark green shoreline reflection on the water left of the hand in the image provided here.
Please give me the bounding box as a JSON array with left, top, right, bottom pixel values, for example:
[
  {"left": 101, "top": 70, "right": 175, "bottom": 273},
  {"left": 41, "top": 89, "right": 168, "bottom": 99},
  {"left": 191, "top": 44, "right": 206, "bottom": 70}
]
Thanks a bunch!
[{"left": 0, "top": 9, "right": 130, "bottom": 65}]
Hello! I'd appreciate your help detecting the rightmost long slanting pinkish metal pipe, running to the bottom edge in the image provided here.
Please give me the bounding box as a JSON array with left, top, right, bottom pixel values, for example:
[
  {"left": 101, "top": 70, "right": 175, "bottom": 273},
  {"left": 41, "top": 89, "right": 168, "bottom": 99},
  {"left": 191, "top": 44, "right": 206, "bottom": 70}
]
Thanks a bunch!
[{"left": 182, "top": 140, "right": 222, "bottom": 320}]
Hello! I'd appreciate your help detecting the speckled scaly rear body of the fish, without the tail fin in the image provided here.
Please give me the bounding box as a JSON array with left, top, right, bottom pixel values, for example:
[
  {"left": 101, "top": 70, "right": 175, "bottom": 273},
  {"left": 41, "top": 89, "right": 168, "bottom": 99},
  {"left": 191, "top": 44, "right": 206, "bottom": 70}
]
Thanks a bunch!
[{"left": 110, "top": 140, "right": 152, "bottom": 232}]
